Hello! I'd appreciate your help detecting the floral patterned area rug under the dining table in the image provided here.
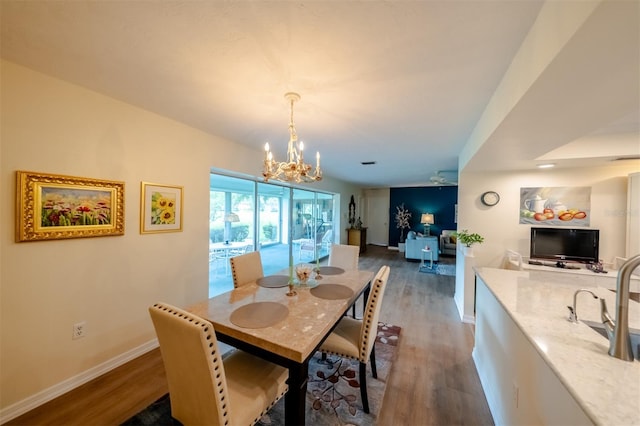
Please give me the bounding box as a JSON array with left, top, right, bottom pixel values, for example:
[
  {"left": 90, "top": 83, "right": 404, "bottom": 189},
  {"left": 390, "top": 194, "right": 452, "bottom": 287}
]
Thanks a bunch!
[{"left": 123, "top": 322, "right": 401, "bottom": 426}]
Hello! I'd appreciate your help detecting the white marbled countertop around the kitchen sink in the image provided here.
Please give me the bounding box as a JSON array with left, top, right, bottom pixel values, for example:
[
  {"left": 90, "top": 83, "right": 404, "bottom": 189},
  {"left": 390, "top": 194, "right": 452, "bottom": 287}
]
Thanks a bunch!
[{"left": 476, "top": 267, "right": 640, "bottom": 425}]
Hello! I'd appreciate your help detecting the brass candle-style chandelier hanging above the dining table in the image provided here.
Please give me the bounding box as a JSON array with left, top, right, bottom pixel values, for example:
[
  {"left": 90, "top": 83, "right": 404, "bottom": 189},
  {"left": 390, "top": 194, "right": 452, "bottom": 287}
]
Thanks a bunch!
[{"left": 262, "top": 92, "right": 322, "bottom": 183}]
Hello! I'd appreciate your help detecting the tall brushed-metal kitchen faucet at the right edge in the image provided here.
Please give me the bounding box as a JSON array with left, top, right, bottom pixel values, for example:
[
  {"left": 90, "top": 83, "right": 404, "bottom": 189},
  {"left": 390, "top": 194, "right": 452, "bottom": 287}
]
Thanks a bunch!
[{"left": 600, "top": 254, "right": 640, "bottom": 361}]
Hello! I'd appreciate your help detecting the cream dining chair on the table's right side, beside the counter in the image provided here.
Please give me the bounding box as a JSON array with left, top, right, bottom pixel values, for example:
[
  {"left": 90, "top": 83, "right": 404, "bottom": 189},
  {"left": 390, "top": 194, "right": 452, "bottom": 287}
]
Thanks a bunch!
[{"left": 319, "top": 265, "right": 390, "bottom": 413}]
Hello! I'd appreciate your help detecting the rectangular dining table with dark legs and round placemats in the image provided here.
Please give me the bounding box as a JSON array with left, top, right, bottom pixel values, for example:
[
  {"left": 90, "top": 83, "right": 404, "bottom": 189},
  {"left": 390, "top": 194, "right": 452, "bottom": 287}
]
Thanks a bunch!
[{"left": 186, "top": 266, "right": 374, "bottom": 425}]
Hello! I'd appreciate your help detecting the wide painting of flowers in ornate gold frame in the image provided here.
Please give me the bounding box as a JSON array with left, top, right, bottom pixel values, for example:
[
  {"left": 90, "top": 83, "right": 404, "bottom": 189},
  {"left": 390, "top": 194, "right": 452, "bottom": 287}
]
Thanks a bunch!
[{"left": 16, "top": 170, "right": 124, "bottom": 242}]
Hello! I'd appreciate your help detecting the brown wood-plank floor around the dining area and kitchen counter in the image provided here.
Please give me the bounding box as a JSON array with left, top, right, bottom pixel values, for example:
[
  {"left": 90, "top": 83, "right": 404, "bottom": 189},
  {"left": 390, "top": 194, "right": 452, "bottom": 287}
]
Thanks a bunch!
[{"left": 6, "top": 246, "right": 493, "bottom": 426}]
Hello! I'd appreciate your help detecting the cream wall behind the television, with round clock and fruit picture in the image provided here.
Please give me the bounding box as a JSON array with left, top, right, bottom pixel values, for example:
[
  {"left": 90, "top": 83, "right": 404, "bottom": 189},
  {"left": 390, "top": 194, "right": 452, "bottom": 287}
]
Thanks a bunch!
[{"left": 456, "top": 165, "right": 640, "bottom": 318}]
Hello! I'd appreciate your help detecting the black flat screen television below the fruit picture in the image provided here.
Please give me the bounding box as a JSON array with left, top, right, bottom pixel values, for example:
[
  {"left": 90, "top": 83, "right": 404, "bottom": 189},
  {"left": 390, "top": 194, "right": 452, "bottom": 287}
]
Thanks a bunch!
[{"left": 529, "top": 227, "right": 600, "bottom": 266}]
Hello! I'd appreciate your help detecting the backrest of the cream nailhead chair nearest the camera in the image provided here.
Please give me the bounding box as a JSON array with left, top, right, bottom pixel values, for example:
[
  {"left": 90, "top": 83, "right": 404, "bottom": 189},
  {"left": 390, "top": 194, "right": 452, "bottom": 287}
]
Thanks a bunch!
[{"left": 149, "top": 303, "right": 229, "bottom": 425}]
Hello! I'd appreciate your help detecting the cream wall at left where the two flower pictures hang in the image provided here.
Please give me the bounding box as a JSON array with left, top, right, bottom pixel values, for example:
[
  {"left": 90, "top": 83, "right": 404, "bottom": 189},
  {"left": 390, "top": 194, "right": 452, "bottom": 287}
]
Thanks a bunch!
[{"left": 0, "top": 61, "right": 360, "bottom": 420}]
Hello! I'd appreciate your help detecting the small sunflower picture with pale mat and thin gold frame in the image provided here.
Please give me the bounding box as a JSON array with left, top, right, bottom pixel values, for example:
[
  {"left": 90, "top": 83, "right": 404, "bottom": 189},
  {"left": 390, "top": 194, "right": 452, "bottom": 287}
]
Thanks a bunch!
[{"left": 140, "top": 182, "right": 183, "bottom": 234}]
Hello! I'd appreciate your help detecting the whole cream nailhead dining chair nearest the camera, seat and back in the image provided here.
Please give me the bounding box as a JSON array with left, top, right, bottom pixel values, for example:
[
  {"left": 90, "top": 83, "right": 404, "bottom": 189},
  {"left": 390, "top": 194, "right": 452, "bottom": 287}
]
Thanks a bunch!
[{"left": 149, "top": 303, "right": 289, "bottom": 426}]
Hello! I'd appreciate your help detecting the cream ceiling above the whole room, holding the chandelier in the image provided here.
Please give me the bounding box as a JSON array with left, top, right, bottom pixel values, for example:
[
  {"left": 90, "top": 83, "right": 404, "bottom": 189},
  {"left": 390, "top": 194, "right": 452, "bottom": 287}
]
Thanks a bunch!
[{"left": 0, "top": 0, "right": 640, "bottom": 187}]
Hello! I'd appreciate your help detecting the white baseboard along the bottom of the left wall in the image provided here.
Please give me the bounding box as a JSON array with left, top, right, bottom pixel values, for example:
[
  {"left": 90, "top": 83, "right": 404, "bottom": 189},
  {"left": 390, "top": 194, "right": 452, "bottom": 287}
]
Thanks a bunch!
[{"left": 0, "top": 339, "right": 158, "bottom": 424}]
